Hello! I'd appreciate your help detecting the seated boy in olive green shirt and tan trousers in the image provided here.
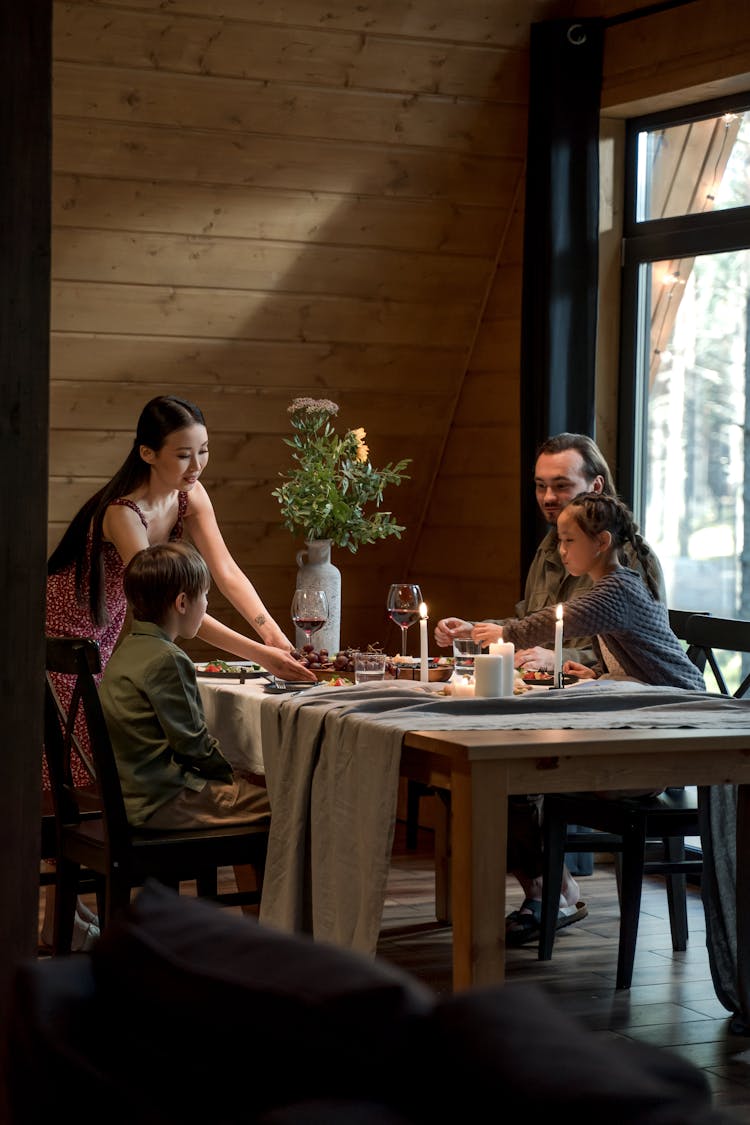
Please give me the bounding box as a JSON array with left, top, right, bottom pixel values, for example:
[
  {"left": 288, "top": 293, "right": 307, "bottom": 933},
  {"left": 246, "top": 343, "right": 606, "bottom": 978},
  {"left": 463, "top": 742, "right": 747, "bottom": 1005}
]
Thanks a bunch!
[{"left": 99, "top": 542, "right": 270, "bottom": 837}]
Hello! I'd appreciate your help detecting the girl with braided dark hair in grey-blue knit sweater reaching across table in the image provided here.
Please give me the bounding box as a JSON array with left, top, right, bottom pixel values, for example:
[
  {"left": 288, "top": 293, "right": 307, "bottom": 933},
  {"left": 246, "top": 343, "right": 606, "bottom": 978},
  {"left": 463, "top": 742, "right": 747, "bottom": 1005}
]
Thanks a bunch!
[{"left": 471, "top": 493, "right": 705, "bottom": 691}]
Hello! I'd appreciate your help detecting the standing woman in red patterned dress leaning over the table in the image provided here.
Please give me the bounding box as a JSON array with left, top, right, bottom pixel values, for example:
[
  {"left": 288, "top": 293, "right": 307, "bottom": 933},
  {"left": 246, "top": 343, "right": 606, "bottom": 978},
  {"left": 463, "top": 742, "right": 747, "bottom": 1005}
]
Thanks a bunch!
[{"left": 43, "top": 395, "right": 315, "bottom": 939}]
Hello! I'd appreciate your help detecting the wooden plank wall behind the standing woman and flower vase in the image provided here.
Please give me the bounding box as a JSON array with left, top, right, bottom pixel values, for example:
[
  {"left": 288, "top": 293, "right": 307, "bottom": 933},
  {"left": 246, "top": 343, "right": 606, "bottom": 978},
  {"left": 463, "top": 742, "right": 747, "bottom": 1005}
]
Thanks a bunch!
[{"left": 49, "top": 0, "right": 560, "bottom": 648}]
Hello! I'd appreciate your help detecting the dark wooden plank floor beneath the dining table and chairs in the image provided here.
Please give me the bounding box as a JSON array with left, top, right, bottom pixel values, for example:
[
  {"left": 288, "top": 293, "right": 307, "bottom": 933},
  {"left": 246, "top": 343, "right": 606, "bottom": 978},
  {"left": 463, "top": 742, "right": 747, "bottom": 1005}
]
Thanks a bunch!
[{"left": 40, "top": 824, "right": 750, "bottom": 1123}]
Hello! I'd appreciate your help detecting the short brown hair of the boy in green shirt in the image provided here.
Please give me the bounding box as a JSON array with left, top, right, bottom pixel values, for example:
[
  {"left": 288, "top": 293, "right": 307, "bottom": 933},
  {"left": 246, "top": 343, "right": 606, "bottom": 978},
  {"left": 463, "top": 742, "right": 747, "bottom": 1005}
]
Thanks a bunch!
[{"left": 123, "top": 542, "right": 211, "bottom": 624}]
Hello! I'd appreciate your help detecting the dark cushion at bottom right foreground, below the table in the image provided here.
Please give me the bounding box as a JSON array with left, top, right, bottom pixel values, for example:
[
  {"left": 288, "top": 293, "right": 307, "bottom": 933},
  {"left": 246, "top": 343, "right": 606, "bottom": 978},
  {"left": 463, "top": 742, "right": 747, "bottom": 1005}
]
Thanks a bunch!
[{"left": 423, "top": 983, "right": 726, "bottom": 1125}]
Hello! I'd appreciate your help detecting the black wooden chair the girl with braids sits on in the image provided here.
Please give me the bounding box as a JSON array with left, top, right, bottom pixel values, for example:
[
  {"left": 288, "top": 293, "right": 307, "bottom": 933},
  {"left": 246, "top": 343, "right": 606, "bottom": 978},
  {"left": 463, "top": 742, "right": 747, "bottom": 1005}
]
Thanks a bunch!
[{"left": 539, "top": 611, "right": 750, "bottom": 989}]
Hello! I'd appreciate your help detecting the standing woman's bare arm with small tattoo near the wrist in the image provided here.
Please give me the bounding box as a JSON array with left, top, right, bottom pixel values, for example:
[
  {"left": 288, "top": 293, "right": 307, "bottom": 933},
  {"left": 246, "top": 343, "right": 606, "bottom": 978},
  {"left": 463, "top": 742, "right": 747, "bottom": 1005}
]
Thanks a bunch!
[{"left": 186, "top": 484, "right": 293, "bottom": 659}]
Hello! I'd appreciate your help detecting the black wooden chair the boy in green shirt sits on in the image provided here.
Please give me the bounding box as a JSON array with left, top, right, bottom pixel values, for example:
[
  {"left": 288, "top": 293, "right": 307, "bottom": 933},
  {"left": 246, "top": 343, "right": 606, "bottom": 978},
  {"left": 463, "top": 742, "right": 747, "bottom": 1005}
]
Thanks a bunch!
[{"left": 45, "top": 637, "right": 269, "bottom": 953}]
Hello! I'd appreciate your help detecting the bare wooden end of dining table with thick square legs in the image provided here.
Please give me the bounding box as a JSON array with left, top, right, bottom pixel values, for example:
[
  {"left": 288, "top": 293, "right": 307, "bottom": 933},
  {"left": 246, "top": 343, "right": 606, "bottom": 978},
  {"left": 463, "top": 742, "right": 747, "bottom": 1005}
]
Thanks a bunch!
[{"left": 400, "top": 727, "right": 750, "bottom": 994}]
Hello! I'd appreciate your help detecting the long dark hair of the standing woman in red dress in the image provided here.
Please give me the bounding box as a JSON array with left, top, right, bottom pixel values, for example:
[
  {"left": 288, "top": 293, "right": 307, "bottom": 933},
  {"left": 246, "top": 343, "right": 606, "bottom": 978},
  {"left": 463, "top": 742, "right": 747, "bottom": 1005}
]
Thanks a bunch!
[{"left": 47, "top": 395, "right": 206, "bottom": 627}]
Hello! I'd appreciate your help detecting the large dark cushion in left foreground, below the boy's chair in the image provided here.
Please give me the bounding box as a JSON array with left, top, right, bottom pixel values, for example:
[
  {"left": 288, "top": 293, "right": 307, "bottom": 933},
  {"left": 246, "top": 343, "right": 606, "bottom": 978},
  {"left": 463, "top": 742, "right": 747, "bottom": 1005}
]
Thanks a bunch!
[{"left": 91, "top": 882, "right": 435, "bottom": 1123}]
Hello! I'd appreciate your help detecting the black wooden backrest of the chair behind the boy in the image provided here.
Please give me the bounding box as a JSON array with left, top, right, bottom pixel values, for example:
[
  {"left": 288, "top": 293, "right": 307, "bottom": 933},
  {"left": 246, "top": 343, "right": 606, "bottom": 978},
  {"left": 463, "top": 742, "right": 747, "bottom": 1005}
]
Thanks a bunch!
[{"left": 45, "top": 637, "right": 132, "bottom": 854}]
